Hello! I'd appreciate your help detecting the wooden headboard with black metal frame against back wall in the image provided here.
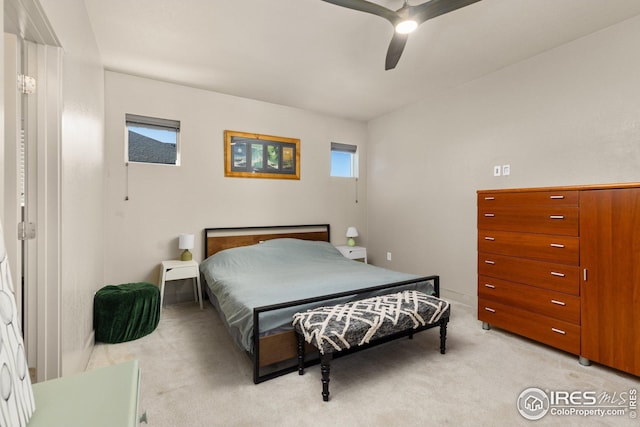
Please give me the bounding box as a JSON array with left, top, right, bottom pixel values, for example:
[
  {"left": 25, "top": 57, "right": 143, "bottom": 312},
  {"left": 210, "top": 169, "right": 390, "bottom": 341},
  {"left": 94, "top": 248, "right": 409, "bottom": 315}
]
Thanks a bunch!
[{"left": 203, "top": 224, "right": 331, "bottom": 258}]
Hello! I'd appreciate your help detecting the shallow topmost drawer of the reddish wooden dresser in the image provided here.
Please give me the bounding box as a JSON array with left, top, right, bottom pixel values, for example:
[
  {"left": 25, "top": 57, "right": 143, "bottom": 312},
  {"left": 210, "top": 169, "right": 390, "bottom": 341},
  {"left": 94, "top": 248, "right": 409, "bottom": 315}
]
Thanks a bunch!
[{"left": 478, "top": 191, "right": 579, "bottom": 207}]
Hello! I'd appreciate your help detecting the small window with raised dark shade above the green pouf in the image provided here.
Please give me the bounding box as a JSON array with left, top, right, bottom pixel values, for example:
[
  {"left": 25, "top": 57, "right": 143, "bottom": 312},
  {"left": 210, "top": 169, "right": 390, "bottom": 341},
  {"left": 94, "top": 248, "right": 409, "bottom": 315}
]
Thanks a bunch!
[{"left": 125, "top": 114, "right": 180, "bottom": 166}]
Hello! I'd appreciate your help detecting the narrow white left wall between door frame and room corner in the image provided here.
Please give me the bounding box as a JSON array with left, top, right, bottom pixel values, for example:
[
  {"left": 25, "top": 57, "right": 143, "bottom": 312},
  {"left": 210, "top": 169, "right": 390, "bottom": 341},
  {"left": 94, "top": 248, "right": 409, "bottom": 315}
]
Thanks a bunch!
[{"left": 40, "top": 0, "right": 104, "bottom": 375}]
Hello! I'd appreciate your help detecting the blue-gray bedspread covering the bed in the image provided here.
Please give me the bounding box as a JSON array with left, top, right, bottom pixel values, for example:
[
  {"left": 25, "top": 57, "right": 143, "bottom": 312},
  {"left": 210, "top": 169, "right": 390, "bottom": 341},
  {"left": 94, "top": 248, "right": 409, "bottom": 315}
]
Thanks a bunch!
[{"left": 200, "top": 239, "right": 429, "bottom": 351}]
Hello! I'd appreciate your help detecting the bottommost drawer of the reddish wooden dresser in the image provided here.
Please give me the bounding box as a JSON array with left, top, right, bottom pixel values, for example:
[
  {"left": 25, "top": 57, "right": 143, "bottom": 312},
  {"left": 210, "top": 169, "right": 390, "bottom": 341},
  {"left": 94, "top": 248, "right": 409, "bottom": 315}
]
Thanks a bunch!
[{"left": 478, "top": 298, "right": 580, "bottom": 354}]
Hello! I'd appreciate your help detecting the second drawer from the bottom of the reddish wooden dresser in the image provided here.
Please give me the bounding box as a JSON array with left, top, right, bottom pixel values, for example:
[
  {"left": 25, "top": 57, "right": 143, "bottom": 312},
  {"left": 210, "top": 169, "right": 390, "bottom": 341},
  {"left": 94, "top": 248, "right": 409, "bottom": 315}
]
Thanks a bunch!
[{"left": 478, "top": 276, "right": 580, "bottom": 325}]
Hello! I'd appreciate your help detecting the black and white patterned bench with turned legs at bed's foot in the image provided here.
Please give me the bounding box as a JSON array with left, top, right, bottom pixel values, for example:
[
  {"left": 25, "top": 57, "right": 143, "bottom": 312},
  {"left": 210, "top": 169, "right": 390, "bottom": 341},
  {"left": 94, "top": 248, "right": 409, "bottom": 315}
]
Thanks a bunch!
[{"left": 293, "top": 291, "right": 451, "bottom": 402}]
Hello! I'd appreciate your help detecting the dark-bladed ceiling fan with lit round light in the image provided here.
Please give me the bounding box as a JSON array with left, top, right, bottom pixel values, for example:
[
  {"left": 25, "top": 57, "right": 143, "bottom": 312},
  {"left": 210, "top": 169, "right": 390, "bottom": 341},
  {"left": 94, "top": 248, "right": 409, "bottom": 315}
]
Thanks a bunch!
[{"left": 323, "top": 0, "right": 480, "bottom": 70}]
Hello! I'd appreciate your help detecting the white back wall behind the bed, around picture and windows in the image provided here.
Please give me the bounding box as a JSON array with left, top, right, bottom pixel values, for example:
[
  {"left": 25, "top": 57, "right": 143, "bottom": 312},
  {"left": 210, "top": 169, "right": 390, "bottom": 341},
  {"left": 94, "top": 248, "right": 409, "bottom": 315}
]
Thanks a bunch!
[{"left": 105, "top": 71, "right": 366, "bottom": 293}]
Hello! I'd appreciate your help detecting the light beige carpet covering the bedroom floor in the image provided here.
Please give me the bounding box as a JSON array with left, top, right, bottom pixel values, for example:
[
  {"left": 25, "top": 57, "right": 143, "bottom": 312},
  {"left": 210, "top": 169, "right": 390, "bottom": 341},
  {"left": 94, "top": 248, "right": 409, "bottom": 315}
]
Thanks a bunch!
[{"left": 88, "top": 303, "right": 639, "bottom": 427}]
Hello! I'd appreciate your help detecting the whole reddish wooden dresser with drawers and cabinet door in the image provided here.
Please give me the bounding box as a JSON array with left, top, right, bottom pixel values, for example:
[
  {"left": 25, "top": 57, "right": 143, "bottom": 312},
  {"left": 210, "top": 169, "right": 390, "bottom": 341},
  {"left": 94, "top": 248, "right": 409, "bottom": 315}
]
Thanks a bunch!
[{"left": 478, "top": 183, "right": 640, "bottom": 375}]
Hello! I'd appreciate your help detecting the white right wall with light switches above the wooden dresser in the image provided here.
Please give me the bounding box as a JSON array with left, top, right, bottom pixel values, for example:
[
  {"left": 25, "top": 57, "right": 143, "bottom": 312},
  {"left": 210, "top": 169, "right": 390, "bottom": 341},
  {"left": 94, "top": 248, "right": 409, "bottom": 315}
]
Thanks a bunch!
[{"left": 367, "top": 17, "right": 640, "bottom": 305}]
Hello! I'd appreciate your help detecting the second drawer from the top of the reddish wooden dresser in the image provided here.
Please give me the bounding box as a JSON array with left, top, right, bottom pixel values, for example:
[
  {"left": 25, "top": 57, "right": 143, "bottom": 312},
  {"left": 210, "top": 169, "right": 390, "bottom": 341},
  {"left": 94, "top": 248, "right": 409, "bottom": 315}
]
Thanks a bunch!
[{"left": 478, "top": 206, "right": 579, "bottom": 236}]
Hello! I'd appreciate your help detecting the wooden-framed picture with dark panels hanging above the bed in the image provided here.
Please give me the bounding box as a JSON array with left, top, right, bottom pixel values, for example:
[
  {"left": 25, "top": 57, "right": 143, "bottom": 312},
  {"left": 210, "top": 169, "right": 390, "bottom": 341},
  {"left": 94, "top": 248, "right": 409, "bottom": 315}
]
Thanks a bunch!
[{"left": 224, "top": 130, "right": 300, "bottom": 179}]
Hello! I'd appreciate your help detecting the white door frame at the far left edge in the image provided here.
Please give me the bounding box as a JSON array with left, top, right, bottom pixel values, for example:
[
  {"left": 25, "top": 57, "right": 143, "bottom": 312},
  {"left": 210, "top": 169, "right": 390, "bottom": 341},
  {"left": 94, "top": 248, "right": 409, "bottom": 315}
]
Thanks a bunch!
[{"left": 2, "top": 0, "right": 63, "bottom": 381}]
